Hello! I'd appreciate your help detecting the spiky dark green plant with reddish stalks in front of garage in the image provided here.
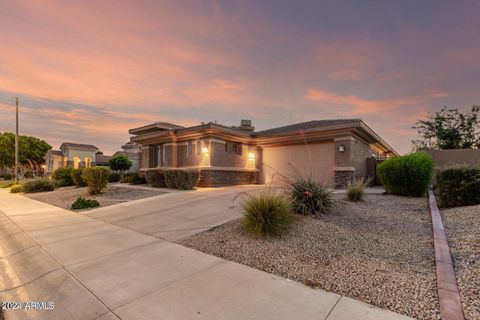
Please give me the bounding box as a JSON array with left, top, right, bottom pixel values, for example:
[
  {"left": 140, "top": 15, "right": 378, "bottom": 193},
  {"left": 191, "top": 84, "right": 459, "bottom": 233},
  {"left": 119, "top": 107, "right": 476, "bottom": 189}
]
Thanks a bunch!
[{"left": 289, "top": 176, "right": 333, "bottom": 215}]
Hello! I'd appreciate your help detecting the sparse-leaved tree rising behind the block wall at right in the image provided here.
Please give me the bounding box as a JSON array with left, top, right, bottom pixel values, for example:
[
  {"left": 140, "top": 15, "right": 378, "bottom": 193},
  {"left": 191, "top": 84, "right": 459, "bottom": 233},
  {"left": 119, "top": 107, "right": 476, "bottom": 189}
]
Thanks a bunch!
[{"left": 413, "top": 106, "right": 480, "bottom": 149}]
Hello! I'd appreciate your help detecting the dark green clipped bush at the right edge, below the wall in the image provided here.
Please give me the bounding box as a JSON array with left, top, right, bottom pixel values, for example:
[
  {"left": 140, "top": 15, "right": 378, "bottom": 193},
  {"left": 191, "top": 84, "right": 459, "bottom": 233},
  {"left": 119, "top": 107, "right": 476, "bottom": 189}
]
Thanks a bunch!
[{"left": 435, "top": 166, "right": 480, "bottom": 207}]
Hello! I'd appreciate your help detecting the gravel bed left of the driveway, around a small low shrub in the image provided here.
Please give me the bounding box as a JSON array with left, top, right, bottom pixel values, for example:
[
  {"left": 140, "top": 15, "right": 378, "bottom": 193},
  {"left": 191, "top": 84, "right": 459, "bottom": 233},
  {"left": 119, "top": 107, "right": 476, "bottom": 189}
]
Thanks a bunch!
[{"left": 24, "top": 186, "right": 165, "bottom": 210}]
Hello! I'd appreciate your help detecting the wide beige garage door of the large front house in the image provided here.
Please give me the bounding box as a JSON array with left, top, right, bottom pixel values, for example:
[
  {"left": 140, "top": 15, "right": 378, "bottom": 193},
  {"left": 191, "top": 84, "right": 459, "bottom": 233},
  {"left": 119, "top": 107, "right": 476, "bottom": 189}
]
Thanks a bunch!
[{"left": 260, "top": 142, "right": 335, "bottom": 186}]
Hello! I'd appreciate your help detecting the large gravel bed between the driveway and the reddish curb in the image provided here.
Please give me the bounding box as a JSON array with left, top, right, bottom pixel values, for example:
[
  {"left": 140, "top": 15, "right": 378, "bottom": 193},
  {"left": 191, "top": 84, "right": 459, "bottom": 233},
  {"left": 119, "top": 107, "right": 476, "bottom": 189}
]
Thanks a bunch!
[{"left": 180, "top": 194, "right": 440, "bottom": 319}]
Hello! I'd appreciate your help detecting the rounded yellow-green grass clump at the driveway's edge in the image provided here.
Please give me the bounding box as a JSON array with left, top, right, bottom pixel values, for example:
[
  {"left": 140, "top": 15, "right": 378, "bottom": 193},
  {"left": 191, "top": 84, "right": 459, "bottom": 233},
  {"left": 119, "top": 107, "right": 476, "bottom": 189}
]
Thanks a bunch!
[{"left": 243, "top": 190, "right": 295, "bottom": 236}]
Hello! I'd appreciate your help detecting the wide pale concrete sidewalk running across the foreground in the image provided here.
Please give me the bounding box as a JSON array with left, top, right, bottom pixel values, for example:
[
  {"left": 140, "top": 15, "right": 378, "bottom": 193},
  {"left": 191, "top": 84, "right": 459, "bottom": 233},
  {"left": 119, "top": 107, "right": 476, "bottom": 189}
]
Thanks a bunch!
[{"left": 0, "top": 190, "right": 409, "bottom": 320}]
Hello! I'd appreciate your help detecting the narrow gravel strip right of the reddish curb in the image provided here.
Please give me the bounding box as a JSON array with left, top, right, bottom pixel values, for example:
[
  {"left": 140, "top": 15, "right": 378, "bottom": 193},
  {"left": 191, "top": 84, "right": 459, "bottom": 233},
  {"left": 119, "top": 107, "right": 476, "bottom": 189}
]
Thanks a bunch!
[{"left": 441, "top": 205, "right": 480, "bottom": 320}]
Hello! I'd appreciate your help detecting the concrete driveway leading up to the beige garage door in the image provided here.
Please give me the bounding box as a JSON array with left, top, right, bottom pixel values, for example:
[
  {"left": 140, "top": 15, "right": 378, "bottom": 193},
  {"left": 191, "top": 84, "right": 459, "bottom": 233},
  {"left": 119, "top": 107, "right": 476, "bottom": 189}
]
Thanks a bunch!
[{"left": 84, "top": 185, "right": 261, "bottom": 241}]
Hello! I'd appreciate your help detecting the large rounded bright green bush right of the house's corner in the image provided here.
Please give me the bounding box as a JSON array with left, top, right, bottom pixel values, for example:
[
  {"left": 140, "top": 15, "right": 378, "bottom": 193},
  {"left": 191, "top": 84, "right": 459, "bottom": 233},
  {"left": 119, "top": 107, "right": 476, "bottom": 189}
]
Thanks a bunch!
[{"left": 377, "top": 152, "right": 433, "bottom": 197}]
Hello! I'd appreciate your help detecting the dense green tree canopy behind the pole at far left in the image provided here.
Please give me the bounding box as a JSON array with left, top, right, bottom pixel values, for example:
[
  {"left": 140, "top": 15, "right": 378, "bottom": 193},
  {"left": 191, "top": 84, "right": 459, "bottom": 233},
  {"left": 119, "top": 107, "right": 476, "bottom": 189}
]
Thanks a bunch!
[{"left": 0, "top": 132, "right": 52, "bottom": 167}]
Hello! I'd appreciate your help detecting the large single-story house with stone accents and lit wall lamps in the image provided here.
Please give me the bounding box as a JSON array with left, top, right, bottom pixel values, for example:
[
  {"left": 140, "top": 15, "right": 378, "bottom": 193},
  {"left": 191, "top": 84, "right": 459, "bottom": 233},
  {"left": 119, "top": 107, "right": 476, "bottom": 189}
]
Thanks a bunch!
[{"left": 129, "top": 119, "right": 396, "bottom": 186}]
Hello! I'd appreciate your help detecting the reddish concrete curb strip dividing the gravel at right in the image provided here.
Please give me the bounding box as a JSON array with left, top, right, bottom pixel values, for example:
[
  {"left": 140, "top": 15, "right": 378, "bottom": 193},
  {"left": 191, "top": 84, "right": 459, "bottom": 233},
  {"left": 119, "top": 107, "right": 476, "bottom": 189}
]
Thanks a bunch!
[{"left": 428, "top": 191, "right": 465, "bottom": 320}]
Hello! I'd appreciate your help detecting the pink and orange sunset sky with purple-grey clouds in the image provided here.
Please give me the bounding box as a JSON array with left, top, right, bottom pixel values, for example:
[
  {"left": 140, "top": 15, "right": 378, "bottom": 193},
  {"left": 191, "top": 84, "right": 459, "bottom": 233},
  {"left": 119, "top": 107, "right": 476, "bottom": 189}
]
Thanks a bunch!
[{"left": 0, "top": 0, "right": 480, "bottom": 154}]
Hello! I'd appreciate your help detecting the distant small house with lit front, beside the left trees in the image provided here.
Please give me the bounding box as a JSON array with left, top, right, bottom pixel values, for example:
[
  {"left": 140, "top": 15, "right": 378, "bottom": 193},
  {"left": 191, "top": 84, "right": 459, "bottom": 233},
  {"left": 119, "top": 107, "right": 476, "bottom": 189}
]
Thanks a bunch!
[{"left": 45, "top": 142, "right": 98, "bottom": 174}]
